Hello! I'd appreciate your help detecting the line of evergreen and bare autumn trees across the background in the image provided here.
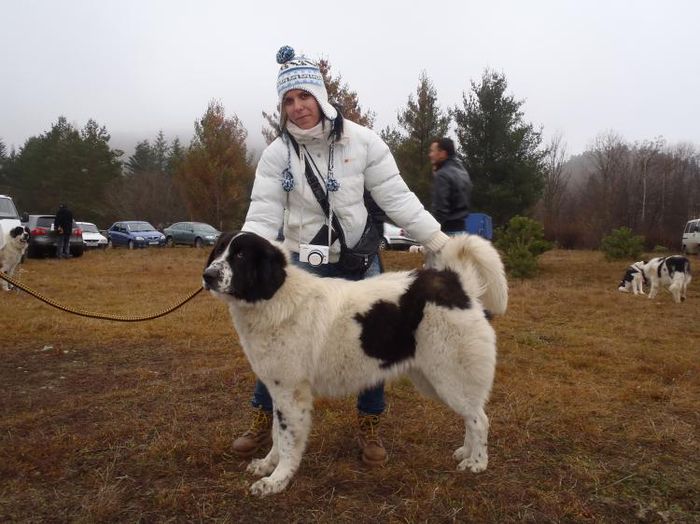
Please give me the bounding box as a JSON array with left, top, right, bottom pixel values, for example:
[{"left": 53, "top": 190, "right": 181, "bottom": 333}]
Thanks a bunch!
[{"left": 0, "top": 60, "right": 700, "bottom": 248}]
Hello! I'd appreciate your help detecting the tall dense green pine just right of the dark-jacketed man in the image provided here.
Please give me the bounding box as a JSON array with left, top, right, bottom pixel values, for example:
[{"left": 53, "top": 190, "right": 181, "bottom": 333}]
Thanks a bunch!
[{"left": 454, "top": 70, "right": 546, "bottom": 225}]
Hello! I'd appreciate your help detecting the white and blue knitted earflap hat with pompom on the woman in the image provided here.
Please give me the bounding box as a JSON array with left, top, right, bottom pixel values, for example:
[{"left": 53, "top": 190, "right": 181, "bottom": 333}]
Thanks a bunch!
[{"left": 277, "top": 45, "right": 338, "bottom": 120}]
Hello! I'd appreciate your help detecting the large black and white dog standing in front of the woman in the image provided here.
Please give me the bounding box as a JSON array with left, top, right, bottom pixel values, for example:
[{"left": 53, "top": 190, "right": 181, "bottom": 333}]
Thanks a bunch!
[{"left": 203, "top": 233, "right": 508, "bottom": 495}]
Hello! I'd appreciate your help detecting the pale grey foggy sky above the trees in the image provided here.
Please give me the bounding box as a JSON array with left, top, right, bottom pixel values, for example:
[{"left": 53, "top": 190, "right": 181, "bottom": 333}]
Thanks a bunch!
[{"left": 0, "top": 0, "right": 700, "bottom": 160}]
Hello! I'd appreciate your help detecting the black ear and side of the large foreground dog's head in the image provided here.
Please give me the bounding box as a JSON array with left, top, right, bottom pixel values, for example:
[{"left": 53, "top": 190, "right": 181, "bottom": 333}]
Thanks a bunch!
[{"left": 231, "top": 234, "right": 287, "bottom": 302}]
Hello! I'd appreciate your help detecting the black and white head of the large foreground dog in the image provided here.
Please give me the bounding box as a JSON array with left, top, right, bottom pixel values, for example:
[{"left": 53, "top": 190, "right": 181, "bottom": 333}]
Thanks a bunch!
[{"left": 202, "top": 233, "right": 287, "bottom": 302}]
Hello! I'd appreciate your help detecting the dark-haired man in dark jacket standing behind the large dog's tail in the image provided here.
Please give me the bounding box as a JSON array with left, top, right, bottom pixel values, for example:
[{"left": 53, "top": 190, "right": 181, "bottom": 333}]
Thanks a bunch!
[{"left": 428, "top": 138, "right": 472, "bottom": 233}]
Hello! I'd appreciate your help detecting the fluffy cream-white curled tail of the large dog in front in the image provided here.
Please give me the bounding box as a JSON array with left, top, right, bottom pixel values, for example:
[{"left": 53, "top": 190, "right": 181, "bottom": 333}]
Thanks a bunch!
[{"left": 438, "top": 235, "right": 508, "bottom": 315}]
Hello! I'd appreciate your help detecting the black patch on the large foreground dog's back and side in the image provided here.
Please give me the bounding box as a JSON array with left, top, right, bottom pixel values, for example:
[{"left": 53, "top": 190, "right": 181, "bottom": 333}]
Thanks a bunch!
[{"left": 355, "top": 269, "right": 471, "bottom": 368}]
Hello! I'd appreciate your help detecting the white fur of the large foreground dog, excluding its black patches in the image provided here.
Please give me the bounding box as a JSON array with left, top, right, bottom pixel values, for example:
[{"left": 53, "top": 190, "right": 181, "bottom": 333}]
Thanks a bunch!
[{"left": 205, "top": 235, "right": 508, "bottom": 495}]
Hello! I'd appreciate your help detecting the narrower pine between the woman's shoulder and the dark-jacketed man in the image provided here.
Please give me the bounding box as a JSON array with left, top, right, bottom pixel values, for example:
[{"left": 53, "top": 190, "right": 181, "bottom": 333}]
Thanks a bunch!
[{"left": 381, "top": 72, "right": 450, "bottom": 207}]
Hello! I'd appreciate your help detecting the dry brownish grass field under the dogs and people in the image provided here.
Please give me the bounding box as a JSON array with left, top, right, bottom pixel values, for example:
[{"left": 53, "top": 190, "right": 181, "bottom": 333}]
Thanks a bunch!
[{"left": 0, "top": 248, "right": 700, "bottom": 523}]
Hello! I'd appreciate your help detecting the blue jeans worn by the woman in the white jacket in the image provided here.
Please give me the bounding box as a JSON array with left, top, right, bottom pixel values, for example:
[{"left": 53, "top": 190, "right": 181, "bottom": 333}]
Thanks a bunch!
[{"left": 251, "top": 253, "right": 384, "bottom": 415}]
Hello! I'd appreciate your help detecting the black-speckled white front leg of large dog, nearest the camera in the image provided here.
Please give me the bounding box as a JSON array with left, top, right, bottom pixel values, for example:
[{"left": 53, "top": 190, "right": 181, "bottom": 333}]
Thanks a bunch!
[{"left": 250, "top": 384, "right": 313, "bottom": 496}]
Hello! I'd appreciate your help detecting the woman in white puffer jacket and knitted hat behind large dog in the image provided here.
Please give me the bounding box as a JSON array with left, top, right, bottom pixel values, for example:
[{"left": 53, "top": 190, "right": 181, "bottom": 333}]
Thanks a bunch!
[{"left": 233, "top": 46, "right": 448, "bottom": 465}]
